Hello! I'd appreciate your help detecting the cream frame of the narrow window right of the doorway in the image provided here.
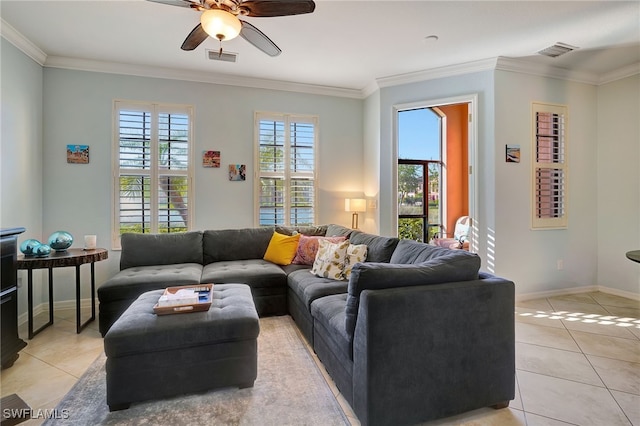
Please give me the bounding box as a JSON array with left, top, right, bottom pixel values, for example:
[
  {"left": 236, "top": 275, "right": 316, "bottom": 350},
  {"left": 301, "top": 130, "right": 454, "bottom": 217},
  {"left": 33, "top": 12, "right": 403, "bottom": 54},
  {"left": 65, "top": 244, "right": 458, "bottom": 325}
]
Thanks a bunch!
[{"left": 531, "top": 102, "right": 569, "bottom": 230}]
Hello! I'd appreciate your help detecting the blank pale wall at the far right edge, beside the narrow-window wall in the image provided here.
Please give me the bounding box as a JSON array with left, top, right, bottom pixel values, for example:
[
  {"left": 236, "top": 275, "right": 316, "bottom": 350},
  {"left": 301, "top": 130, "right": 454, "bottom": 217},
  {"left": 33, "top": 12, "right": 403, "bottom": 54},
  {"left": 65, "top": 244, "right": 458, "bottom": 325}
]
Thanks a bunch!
[{"left": 597, "top": 75, "right": 640, "bottom": 295}]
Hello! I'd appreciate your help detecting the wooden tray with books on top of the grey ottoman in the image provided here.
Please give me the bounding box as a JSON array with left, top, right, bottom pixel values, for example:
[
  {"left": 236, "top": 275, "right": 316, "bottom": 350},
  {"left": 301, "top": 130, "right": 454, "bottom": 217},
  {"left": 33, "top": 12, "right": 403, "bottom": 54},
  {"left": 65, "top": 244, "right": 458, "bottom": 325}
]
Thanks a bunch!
[{"left": 153, "top": 284, "right": 213, "bottom": 315}]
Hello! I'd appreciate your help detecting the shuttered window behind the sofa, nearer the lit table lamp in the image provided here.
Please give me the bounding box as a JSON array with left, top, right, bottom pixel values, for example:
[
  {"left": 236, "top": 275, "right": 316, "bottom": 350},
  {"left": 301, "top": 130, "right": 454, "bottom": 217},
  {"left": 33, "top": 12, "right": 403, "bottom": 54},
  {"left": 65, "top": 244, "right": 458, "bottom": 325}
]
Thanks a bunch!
[{"left": 255, "top": 113, "right": 318, "bottom": 226}]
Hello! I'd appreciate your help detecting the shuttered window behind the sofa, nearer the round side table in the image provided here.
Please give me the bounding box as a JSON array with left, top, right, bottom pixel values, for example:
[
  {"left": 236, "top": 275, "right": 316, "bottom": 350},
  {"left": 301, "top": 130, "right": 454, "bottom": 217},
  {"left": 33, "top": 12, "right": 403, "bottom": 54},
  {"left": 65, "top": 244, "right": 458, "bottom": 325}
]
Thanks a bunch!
[{"left": 113, "top": 101, "right": 193, "bottom": 248}]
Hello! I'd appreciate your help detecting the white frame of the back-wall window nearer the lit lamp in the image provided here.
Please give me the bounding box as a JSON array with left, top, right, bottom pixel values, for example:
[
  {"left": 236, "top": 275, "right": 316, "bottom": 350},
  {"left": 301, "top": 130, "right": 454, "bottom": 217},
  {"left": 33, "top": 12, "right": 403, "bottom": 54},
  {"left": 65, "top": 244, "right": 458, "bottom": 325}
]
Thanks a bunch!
[{"left": 254, "top": 111, "right": 319, "bottom": 227}]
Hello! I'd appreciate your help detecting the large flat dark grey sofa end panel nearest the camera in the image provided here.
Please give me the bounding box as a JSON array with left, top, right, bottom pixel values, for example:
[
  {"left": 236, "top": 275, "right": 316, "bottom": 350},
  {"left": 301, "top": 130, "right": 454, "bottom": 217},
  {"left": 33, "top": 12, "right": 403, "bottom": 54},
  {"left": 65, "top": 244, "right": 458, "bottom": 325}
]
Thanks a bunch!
[{"left": 353, "top": 276, "right": 515, "bottom": 425}]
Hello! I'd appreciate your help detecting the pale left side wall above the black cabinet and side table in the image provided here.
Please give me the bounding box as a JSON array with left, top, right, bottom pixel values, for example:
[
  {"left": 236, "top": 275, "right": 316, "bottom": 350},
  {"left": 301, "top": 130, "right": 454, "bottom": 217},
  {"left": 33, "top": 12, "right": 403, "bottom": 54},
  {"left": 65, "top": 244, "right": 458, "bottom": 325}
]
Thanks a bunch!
[{"left": 0, "top": 38, "right": 42, "bottom": 312}]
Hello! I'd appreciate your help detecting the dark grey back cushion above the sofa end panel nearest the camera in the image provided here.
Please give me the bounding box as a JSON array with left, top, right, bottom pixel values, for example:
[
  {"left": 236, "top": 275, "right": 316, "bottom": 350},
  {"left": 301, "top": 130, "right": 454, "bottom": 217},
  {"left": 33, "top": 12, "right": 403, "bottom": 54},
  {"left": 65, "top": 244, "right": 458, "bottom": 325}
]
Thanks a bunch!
[{"left": 345, "top": 249, "right": 480, "bottom": 336}]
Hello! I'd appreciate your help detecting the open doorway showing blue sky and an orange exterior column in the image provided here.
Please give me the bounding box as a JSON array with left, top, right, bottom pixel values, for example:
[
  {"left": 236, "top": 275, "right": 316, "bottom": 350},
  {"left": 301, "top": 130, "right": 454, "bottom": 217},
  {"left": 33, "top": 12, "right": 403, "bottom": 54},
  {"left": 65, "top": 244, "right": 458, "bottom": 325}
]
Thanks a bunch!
[{"left": 394, "top": 95, "right": 477, "bottom": 246}]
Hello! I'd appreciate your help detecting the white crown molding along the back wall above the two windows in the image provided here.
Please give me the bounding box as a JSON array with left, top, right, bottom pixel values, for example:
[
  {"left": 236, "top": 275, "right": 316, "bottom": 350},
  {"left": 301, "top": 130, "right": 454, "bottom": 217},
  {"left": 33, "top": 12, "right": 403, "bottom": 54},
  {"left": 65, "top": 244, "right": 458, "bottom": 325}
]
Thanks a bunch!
[{"left": 44, "top": 56, "right": 362, "bottom": 99}]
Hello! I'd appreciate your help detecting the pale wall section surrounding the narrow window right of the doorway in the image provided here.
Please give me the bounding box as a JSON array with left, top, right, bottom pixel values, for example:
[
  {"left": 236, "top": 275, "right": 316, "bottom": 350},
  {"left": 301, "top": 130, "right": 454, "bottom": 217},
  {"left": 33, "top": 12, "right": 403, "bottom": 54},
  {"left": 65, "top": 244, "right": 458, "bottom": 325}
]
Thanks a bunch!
[{"left": 495, "top": 71, "right": 598, "bottom": 294}]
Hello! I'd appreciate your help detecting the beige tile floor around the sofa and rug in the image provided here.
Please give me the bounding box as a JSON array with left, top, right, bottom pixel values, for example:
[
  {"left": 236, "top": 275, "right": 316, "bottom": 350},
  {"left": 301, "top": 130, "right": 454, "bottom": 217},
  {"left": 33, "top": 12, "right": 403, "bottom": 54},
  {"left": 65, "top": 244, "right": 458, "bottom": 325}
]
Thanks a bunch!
[{"left": 0, "top": 292, "right": 640, "bottom": 426}]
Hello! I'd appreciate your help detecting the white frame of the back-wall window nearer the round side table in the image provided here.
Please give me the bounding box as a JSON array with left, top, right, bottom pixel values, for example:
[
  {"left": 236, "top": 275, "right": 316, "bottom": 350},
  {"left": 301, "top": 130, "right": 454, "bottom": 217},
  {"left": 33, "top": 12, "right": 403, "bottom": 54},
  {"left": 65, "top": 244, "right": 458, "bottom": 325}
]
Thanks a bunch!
[{"left": 111, "top": 99, "right": 195, "bottom": 250}]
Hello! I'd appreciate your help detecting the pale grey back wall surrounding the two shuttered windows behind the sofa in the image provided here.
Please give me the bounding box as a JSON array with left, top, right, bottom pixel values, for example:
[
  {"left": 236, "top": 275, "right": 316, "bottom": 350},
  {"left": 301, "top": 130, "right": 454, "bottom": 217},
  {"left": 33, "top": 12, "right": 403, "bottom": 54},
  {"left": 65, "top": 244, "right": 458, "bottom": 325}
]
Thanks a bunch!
[{"left": 30, "top": 68, "right": 363, "bottom": 300}]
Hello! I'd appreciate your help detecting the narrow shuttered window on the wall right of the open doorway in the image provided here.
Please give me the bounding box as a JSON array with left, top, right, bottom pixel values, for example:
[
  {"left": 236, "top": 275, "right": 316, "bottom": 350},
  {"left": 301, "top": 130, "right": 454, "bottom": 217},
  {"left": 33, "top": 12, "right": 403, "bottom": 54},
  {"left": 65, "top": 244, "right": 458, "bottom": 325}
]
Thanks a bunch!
[{"left": 532, "top": 103, "right": 567, "bottom": 229}]
